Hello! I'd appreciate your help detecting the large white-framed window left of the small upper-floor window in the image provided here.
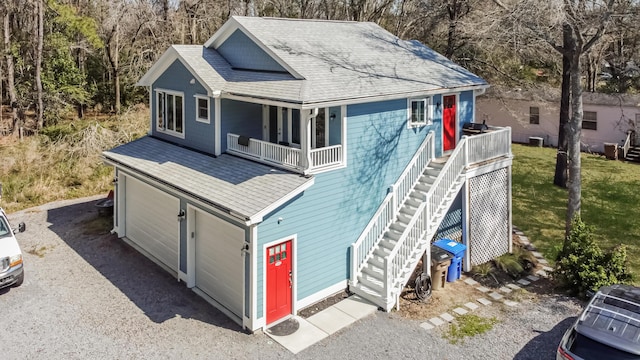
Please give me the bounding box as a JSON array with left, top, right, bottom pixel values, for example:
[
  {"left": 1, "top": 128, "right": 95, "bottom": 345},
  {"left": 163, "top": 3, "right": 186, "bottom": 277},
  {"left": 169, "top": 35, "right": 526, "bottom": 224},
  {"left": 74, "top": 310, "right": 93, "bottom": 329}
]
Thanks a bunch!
[{"left": 156, "top": 90, "right": 184, "bottom": 137}]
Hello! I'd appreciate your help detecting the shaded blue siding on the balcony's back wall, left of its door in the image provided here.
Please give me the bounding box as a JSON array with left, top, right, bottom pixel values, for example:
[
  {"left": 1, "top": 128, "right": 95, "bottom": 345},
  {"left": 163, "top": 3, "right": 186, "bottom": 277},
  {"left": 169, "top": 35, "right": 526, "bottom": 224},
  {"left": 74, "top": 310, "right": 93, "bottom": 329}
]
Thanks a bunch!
[{"left": 220, "top": 99, "right": 262, "bottom": 152}]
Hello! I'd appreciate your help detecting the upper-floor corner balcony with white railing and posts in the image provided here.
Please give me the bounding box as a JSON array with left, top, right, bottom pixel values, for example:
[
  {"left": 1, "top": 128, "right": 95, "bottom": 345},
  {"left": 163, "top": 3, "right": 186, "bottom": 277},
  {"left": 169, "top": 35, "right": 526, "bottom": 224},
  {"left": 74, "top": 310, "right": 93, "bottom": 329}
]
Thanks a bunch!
[{"left": 223, "top": 105, "right": 346, "bottom": 174}]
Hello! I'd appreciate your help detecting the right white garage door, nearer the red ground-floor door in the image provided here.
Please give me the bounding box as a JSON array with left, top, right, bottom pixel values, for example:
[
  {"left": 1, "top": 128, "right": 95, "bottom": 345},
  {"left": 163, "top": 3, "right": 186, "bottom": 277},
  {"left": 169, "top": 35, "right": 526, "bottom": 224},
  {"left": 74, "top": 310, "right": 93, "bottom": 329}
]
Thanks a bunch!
[{"left": 195, "top": 210, "right": 244, "bottom": 317}]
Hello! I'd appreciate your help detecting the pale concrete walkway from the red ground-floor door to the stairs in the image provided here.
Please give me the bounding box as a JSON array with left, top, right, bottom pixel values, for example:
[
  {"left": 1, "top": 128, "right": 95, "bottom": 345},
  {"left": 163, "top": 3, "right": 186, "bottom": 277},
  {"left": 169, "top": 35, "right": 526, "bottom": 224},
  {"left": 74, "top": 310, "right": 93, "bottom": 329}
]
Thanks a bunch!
[{"left": 265, "top": 295, "right": 378, "bottom": 354}]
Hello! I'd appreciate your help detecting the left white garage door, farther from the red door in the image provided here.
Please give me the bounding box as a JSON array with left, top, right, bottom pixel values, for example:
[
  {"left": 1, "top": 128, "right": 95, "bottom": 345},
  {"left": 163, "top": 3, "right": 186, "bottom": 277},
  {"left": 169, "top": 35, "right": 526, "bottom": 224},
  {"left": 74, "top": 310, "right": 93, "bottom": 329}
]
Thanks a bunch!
[{"left": 125, "top": 176, "right": 180, "bottom": 272}]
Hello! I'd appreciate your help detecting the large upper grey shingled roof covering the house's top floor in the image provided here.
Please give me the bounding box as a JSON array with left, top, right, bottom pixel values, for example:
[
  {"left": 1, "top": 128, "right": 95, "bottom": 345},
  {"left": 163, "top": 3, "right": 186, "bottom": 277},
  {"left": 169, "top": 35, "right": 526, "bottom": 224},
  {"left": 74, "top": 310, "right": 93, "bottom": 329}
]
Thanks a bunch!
[{"left": 139, "top": 16, "right": 487, "bottom": 107}]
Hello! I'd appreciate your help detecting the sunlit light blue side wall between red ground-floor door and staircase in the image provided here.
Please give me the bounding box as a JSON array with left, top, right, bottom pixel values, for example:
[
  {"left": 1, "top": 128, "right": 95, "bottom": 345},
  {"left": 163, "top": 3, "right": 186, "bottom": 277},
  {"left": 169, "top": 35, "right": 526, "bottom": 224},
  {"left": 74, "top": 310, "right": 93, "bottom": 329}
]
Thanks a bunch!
[{"left": 252, "top": 99, "right": 438, "bottom": 317}]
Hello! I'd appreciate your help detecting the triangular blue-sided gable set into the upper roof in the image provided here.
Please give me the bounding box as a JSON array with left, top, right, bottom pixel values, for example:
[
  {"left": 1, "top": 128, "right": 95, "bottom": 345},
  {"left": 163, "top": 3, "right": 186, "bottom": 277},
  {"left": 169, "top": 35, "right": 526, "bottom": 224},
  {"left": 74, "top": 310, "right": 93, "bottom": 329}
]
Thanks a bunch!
[{"left": 217, "top": 30, "right": 286, "bottom": 72}]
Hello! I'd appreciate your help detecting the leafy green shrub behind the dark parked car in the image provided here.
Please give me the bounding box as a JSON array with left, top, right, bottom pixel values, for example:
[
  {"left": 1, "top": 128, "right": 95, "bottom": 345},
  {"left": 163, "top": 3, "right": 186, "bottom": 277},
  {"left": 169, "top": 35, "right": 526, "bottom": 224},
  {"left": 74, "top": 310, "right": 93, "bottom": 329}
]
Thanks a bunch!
[{"left": 555, "top": 218, "right": 632, "bottom": 296}]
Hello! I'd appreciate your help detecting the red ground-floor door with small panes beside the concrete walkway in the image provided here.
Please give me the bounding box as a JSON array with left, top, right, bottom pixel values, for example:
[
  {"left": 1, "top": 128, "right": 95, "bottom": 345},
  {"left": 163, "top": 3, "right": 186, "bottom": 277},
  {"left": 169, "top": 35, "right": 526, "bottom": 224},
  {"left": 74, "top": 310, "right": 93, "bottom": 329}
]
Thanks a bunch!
[{"left": 265, "top": 240, "right": 293, "bottom": 324}]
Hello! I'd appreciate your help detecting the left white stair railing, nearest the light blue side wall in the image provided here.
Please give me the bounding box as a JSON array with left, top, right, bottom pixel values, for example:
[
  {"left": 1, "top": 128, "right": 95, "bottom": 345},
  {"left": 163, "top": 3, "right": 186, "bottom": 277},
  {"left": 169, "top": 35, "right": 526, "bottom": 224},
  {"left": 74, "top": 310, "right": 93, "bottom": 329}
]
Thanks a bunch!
[{"left": 351, "top": 131, "right": 435, "bottom": 285}]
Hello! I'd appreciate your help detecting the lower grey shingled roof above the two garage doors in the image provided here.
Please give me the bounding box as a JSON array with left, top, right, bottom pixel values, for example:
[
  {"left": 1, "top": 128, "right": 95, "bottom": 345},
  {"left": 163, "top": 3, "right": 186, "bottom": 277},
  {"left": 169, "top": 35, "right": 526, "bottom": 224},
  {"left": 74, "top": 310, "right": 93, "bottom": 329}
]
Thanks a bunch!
[{"left": 103, "top": 136, "right": 314, "bottom": 223}]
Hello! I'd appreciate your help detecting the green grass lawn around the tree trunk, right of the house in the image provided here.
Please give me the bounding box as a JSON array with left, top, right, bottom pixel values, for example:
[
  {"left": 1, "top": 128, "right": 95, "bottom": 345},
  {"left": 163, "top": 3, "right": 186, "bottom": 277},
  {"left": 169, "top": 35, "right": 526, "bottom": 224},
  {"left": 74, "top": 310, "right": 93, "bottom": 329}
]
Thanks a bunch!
[{"left": 512, "top": 144, "right": 640, "bottom": 278}]
